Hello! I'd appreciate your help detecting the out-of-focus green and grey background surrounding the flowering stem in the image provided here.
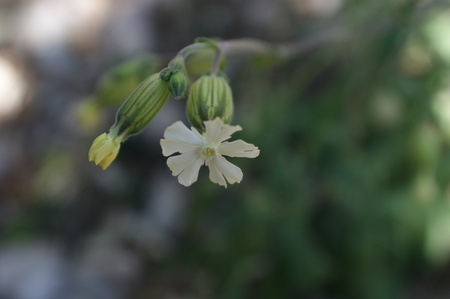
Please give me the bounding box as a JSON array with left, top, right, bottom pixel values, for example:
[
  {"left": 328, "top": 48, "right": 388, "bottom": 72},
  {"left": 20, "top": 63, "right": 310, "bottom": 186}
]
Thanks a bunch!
[{"left": 0, "top": 0, "right": 450, "bottom": 299}]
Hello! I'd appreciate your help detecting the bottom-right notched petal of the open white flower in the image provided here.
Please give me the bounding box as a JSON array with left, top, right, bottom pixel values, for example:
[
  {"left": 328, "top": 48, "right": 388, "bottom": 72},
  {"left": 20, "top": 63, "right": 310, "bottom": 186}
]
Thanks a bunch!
[{"left": 207, "top": 156, "right": 243, "bottom": 187}]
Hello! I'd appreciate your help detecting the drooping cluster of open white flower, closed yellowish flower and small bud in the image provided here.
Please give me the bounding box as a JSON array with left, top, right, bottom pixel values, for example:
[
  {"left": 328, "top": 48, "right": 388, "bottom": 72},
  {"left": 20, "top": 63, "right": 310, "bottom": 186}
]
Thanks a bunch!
[{"left": 89, "top": 40, "right": 259, "bottom": 187}]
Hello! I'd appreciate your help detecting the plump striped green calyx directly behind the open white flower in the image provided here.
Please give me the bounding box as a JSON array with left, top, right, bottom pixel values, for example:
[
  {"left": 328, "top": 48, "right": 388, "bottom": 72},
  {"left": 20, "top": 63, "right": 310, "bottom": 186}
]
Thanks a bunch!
[{"left": 187, "top": 75, "right": 233, "bottom": 130}]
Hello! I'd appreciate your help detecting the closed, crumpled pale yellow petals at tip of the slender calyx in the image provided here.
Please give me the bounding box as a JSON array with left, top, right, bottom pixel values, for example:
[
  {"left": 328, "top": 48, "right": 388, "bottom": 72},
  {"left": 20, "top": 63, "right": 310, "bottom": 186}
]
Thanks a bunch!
[{"left": 89, "top": 133, "right": 121, "bottom": 170}]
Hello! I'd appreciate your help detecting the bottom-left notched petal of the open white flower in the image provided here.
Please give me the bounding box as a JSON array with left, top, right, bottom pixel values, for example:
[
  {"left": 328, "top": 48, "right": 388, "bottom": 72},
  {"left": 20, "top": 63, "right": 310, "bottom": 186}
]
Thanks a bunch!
[{"left": 167, "top": 152, "right": 204, "bottom": 187}]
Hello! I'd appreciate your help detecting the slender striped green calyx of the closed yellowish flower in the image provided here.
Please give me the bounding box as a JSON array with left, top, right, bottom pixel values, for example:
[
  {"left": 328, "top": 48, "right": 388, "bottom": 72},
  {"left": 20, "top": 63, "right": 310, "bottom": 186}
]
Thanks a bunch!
[{"left": 110, "top": 73, "right": 169, "bottom": 140}]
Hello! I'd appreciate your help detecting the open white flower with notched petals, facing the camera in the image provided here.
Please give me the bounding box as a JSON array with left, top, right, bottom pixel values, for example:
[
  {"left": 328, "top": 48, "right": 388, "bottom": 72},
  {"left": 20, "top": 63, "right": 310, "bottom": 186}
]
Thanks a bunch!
[{"left": 161, "top": 117, "right": 259, "bottom": 187}]
